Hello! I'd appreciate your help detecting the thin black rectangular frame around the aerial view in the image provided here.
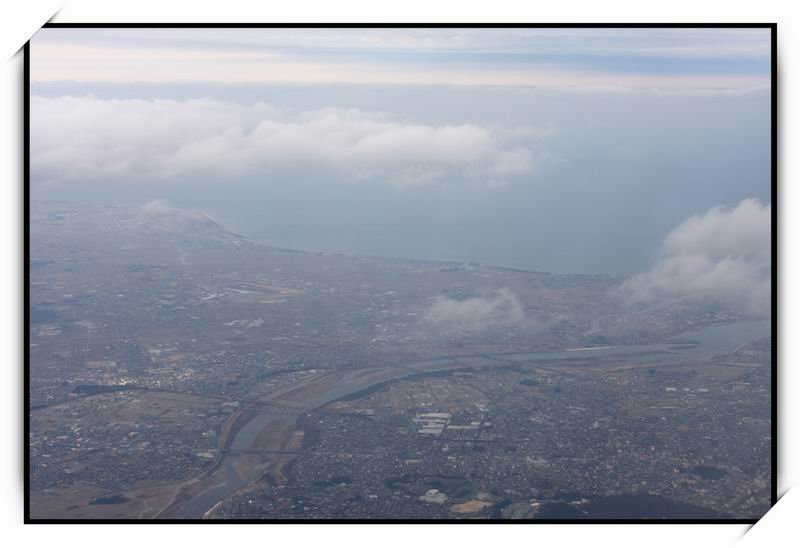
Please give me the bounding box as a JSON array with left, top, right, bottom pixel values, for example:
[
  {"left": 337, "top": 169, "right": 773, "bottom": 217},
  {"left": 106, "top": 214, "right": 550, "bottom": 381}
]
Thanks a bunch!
[{"left": 22, "top": 22, "right": 780, "bottom": 525}]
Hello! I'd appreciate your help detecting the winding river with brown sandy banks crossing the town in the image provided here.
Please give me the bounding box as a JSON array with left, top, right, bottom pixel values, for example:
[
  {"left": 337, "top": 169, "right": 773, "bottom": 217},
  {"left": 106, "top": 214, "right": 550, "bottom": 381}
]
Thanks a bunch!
[{"left": 152, "top": 320, "right": 770, "bottom": 518}]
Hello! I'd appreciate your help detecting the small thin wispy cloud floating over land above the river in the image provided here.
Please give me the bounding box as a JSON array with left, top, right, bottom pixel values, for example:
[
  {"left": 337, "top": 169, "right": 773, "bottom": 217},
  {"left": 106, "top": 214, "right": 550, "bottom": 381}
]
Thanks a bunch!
[{"left": 423, "top": 288, "right": 525, "bottom": 333}]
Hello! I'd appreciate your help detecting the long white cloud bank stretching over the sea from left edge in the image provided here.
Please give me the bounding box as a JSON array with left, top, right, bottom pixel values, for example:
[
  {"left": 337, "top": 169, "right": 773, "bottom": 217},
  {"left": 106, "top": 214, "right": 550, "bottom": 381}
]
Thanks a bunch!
[{"left": 31, "top": 96, "right": 542, "bottom": 185}]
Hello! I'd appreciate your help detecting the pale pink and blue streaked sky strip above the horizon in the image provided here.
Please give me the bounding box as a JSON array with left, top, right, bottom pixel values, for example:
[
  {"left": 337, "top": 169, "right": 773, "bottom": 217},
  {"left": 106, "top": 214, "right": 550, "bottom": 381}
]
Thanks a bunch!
[{"left": 32, "top": 28, "right": 770, "bottom": 89}]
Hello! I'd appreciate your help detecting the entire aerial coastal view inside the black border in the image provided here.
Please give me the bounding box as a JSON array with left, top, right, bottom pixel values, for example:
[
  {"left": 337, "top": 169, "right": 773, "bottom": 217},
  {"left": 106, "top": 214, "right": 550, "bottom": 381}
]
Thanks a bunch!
[{"left": 25, "top": 24, "right": 778, "bottom": 524}]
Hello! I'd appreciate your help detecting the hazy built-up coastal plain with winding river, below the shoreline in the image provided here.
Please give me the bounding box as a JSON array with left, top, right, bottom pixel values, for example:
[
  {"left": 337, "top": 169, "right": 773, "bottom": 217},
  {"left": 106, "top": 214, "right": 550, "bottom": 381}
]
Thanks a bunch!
[{"left": 29, "top": 200, "right": 772, "bottom": 519}]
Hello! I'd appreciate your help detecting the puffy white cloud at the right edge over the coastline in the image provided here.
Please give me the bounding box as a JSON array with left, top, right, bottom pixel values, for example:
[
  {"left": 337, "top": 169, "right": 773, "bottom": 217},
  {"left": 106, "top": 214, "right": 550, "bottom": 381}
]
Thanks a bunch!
[{"left": 621, "top": 199, "right": 772, "bottom": 314}]
